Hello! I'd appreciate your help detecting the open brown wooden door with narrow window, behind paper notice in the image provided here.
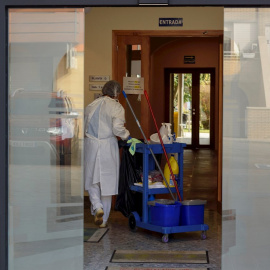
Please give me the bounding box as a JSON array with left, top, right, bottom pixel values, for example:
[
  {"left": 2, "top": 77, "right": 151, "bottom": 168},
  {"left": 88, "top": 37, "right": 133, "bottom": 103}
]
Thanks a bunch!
[{"left": 113, "top": 31, "right": 150, "bottom": 138}]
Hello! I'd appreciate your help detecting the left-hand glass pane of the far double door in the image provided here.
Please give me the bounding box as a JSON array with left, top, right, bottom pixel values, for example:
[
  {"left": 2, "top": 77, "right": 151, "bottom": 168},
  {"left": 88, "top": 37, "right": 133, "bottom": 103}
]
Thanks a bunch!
[{"left": 174, "top": 73, "right": 192, "bottom": 144}]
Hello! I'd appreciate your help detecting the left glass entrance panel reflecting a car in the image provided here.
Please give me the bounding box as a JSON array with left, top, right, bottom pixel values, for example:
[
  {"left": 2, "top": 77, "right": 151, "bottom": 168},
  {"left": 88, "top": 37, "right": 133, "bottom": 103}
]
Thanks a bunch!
[{"left": 9, "top": 9, "right": 84, "bottom": 270}]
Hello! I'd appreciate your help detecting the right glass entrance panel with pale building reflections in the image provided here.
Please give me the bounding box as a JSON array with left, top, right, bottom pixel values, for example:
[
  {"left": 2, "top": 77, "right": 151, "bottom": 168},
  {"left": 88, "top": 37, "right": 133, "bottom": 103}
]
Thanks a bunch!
[{"left": 222, "top": 8, "right": 270, "bottom": 270}]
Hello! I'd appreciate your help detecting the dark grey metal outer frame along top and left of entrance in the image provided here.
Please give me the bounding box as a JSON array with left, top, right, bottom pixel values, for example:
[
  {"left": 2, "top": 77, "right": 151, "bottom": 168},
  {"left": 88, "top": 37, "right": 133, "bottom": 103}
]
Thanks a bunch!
[{"left": 0, "top": 0, "right": 264, "bottom": 270}]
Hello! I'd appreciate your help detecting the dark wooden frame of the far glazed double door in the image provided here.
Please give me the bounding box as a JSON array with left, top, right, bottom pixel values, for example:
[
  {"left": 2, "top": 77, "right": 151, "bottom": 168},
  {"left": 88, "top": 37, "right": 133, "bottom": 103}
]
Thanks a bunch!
[{"left": 164, "top": 67, "right": 216, "bottom": 149}]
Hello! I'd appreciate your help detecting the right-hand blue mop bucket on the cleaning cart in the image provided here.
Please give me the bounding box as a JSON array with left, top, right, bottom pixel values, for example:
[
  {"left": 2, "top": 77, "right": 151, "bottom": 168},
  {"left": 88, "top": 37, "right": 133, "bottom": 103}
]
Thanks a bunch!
[{"left": 180, "top": 200, "right": 206, "bottom": 226}]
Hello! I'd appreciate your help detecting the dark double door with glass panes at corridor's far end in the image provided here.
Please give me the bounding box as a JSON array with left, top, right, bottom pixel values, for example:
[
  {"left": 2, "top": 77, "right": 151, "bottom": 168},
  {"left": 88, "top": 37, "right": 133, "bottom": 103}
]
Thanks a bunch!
[{"left": 165, "top": 68, "right": 215, "bottom": 149}]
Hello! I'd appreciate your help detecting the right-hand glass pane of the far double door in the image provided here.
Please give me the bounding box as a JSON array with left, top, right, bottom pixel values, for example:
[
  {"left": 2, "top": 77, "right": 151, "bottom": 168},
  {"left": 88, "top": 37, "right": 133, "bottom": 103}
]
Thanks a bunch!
[{"left": 199, "top": 73, "right": 211, "bottom": 145}]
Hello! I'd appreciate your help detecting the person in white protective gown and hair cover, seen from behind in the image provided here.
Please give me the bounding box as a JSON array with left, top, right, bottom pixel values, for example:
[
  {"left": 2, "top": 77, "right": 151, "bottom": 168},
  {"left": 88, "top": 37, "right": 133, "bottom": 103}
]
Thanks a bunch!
[{"left": 84, "top": 80, "right": 130, "bottom": 227}]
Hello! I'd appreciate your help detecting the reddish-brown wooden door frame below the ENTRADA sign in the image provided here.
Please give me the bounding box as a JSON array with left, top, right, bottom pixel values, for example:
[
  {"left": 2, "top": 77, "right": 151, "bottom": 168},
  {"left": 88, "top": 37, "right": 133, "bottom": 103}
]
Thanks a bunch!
[{"left": 112, "top": 30, "right": 223, "bottom": 213}]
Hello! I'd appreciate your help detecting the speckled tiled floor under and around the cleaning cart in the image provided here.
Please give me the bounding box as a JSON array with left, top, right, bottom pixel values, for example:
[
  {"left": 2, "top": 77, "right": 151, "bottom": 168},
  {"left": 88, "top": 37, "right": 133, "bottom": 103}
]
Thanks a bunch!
[{"left": 84, "top": 150, "right": 221, "bottom": 270}]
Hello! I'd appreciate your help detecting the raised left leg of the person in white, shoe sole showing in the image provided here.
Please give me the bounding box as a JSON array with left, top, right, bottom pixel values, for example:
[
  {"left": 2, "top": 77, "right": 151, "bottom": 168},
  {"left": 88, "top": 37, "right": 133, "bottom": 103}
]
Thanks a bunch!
[{"left": 88, "top": 184, "right": 104, "bottom": 225}]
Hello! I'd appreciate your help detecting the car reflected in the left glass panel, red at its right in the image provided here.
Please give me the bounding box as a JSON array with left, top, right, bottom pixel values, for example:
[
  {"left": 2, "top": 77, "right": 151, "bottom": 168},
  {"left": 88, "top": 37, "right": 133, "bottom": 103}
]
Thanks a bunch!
[{"left": 9, "top": 90, "right": 79, "bottom": 165}]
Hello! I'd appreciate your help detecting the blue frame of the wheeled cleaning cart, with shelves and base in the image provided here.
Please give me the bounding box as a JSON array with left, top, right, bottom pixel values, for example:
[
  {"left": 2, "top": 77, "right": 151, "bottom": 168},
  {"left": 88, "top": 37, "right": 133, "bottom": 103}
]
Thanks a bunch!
[{"left": 129, "top": 142, "right": 209, "bottom": 243}]
